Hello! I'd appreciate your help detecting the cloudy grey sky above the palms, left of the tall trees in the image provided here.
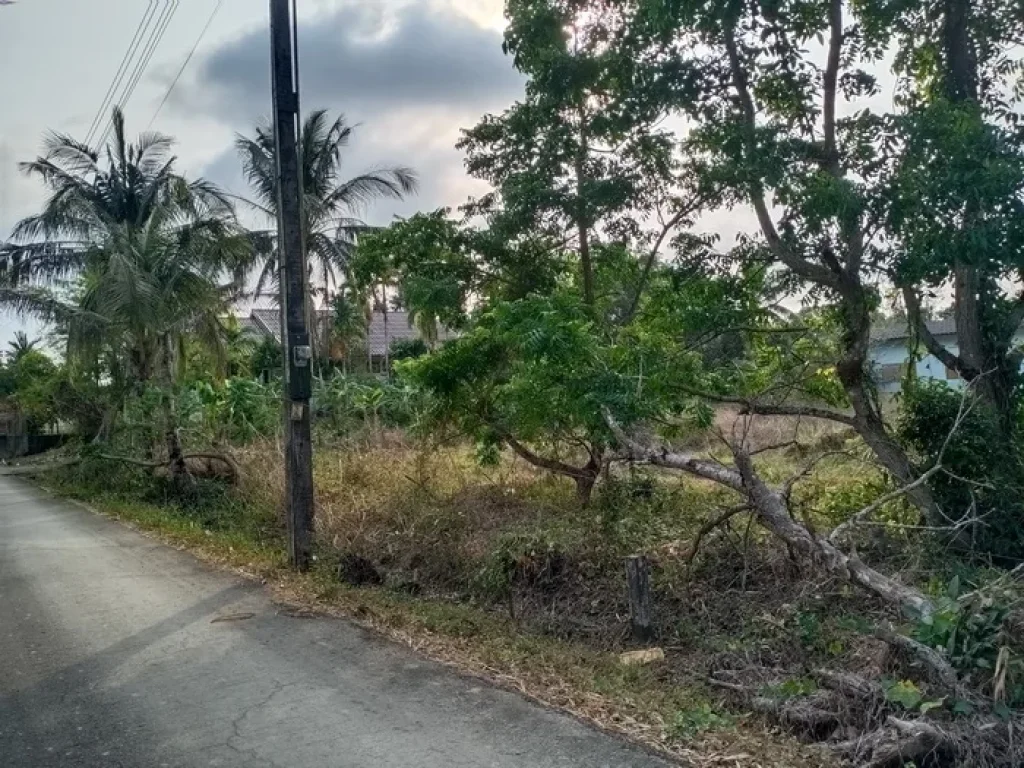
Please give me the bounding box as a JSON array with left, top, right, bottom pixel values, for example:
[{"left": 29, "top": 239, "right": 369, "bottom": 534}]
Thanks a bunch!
[{"left": 0, "top": 0, "right": 522, "bottom": 345}]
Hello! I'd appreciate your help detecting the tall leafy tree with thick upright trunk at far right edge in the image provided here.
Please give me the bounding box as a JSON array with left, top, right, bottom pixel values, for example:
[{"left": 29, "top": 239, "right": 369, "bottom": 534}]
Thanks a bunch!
[{"left": 876, "top": 0, "right": 1024, "bottom": 430}]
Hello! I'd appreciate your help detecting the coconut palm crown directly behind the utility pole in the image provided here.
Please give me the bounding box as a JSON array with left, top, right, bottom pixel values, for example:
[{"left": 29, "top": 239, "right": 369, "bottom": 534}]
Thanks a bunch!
[{"left": 236, "top": 110, "right": 418, "bottom": 305}]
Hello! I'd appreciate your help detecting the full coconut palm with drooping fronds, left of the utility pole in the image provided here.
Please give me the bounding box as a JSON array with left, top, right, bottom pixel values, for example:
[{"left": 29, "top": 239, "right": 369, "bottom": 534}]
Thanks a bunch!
[{"left": 0, "top": 110, "right": 245, "bottom": 477}]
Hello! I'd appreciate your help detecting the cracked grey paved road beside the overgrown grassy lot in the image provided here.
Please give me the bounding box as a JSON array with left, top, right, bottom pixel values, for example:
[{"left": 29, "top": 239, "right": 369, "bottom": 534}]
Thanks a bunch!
[{"left": 0, "top": 477, "right": 666, "bottom": 768}]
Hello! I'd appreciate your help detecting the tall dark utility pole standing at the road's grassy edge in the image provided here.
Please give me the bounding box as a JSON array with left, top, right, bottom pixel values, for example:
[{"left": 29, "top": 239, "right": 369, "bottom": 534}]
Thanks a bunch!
[{"left": 270, "top": 0, "right": 313, "bottom": 570}]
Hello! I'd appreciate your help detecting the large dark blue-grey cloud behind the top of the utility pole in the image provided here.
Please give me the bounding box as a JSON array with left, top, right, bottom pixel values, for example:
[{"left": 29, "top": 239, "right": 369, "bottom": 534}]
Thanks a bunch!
[{"left": 175, "top": 2, "right": 522, "bottom": 126}]
